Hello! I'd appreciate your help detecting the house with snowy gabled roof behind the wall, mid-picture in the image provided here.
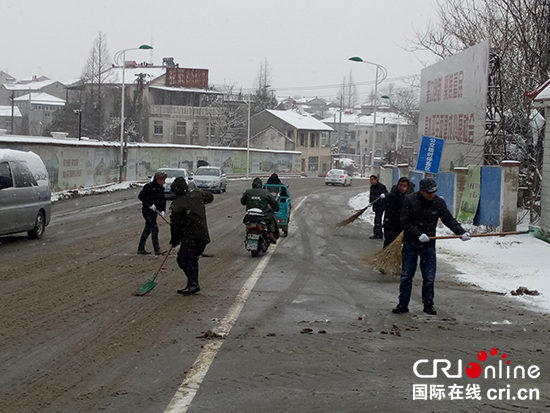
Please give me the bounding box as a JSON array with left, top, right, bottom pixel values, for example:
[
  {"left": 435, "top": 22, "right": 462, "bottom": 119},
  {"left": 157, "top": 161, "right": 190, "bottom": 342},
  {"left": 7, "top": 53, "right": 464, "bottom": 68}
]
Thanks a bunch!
[{"left": 250, "top": 109, "right": 333, "bottom": 176}]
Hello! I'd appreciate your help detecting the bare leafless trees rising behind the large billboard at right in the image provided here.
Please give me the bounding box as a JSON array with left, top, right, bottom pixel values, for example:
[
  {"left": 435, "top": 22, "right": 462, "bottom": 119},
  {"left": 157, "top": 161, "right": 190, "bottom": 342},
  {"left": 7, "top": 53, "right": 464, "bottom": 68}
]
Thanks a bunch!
[{"left": 414, "top": 0, "right": 550, "bottom": 222}]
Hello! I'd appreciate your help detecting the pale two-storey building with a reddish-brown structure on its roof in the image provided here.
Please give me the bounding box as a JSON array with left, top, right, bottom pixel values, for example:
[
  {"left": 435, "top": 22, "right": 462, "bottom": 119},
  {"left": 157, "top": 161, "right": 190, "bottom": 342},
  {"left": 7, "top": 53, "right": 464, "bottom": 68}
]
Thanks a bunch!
[{"left": 72, "top": 63, "right": 224, "bottom": 145}]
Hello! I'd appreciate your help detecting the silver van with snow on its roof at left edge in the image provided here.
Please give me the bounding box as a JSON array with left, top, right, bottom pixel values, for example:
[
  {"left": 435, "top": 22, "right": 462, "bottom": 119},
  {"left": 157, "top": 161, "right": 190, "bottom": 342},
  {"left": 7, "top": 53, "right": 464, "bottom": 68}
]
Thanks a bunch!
[{"left": 0, "top": 149, "right": 52, "bottom": 238}]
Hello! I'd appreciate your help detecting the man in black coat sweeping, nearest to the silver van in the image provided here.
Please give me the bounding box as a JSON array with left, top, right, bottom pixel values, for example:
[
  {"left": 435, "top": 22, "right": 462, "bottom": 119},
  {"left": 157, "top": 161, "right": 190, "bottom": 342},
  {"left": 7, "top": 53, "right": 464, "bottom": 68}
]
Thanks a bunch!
[{"left": 138, "top": 172, "right": 167, "bottom": 255}]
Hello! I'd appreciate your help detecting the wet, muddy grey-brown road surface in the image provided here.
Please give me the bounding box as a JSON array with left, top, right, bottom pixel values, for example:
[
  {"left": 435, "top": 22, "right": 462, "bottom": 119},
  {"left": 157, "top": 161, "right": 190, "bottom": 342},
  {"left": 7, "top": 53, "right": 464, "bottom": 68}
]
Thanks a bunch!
[{"left": 0, "top": 179, "right": 550, "bottom": 413}]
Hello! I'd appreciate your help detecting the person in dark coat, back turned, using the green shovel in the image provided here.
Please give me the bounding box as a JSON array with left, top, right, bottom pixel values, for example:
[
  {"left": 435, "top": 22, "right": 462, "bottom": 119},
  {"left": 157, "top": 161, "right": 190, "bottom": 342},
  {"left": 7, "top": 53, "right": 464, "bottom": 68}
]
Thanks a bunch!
[{"left": 170, "top": 177, "right": 214, "bottom": 295}]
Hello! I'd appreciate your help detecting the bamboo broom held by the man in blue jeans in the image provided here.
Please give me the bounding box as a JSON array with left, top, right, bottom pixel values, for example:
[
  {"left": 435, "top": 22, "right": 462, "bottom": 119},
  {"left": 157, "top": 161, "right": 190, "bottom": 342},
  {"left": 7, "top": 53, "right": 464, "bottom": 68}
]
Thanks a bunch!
[{"left": 365, "top": 231, "right": 529, "bottom": 275}]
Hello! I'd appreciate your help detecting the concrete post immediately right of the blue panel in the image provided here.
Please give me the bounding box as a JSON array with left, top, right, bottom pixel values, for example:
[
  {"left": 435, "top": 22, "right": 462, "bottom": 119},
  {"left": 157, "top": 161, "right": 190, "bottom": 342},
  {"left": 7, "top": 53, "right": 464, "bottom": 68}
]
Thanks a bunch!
[{"left": 500, "top": 161, "right": 521, "bottom": 232}]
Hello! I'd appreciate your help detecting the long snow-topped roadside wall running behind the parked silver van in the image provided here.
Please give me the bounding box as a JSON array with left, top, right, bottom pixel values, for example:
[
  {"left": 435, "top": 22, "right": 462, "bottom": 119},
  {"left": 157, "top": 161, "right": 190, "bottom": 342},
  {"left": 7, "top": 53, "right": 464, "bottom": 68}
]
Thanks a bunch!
[{"left": 0, "top": 135, "right": 301, "bottom": 191}]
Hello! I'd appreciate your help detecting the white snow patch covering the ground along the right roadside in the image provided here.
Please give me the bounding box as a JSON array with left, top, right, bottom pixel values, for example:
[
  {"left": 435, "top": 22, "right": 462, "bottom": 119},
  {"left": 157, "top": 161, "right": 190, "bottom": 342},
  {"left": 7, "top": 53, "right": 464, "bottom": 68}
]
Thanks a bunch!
[{"left": 349, "top": 192, "right": 550, "bottom": 312}]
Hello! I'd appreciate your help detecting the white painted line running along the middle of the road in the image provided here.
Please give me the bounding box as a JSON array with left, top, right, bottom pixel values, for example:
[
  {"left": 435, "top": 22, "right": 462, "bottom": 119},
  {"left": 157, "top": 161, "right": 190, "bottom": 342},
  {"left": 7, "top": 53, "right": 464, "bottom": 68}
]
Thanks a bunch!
[{"left": 164, "top": 196, "right": 307, "bottom": 413}]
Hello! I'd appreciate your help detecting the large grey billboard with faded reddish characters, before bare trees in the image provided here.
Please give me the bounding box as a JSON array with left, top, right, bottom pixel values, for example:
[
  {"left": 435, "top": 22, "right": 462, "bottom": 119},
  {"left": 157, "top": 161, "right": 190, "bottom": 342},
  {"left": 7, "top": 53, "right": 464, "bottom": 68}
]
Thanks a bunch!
[{"left": 418, "top": 41, "right": 489, "bottom": 172}]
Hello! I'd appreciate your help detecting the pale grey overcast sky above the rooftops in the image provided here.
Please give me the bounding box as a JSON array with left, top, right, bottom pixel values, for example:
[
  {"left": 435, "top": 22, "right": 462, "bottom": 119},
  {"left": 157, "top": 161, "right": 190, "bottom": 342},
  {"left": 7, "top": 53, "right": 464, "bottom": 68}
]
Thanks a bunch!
[{"left": 0, "top": 0, "right": 436, "bottom": 98}]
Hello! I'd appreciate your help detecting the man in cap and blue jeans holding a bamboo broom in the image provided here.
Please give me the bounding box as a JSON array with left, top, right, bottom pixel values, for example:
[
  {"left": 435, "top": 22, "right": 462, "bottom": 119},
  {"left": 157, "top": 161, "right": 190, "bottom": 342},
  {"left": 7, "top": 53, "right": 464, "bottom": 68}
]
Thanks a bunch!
[{"left": 392, "top": 178, "right": 470, "bottom": 315}]
